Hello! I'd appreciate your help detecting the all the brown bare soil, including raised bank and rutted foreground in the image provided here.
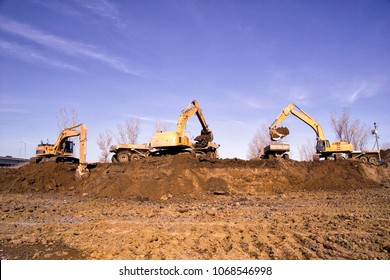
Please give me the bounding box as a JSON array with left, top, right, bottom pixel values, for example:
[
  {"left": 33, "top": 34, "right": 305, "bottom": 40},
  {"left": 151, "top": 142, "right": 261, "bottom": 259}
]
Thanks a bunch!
[{"left": 0, "top": 155, "right": 390, "bottom": 260}]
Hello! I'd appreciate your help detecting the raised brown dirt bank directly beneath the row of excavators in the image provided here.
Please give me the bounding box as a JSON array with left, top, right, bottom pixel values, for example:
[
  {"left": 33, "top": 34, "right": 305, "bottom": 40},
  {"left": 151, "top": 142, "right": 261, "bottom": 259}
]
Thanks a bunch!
[{"left": 0, "top": 155, "right": 389, "bottom": 201}]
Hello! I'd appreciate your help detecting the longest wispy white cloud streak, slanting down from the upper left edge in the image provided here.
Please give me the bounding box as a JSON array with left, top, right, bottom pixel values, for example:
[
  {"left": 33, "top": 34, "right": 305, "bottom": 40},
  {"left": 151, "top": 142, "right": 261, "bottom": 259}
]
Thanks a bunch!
[{"left": 0, "top": 16, "right": 139, "bottom": 75}]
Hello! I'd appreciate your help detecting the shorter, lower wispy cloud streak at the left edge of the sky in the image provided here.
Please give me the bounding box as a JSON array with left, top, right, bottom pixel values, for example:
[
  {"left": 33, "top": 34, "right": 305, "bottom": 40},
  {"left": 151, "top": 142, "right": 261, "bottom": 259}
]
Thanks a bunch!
[{"left": 0, "top": 40, "right": 82, "bottom": 72}]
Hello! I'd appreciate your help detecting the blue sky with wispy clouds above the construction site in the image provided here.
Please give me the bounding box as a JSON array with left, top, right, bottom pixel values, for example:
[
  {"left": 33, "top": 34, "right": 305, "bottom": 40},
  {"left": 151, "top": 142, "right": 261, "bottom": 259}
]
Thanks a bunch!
[{"left": 0, "top": 0, "right": 390, "bottom": 161}]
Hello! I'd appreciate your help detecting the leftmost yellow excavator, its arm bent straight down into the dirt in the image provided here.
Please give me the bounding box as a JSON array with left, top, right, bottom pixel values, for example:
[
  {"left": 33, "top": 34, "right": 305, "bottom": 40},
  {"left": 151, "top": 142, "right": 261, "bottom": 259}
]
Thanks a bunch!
[{"left": 31, "top": 123, "right": 87, "bottom": 174}]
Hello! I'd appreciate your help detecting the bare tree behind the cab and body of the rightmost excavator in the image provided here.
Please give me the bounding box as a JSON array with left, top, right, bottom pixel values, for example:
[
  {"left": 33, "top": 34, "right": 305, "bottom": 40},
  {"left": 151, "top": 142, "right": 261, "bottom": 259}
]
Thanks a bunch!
[{"left": 330, "top": 109, "right": 370, "bottom": 150}]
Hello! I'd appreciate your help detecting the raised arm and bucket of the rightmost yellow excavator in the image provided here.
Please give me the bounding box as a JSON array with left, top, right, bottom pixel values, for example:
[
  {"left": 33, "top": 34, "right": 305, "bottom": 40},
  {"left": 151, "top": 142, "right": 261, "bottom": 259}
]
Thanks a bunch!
[{"left": 269, "top": 103, "right": 326, "bottom": 141}]
